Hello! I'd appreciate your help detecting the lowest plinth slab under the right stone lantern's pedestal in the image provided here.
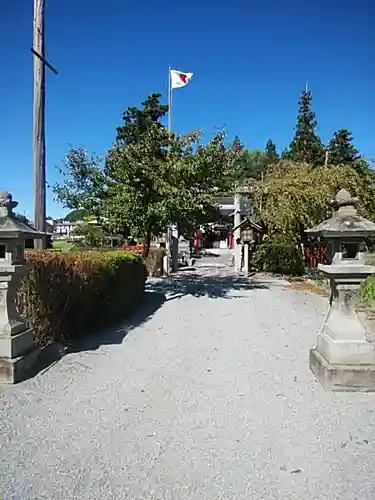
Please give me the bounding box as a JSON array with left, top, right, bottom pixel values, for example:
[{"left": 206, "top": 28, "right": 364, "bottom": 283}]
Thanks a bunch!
[{"left": 310, "top": 348, "right": 375, "bottom": 392}]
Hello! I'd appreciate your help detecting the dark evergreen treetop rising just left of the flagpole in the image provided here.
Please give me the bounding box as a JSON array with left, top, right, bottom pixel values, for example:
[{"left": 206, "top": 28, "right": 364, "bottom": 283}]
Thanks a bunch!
[{"left": 116, "top": 94, "right": 168, "bottom": 146}]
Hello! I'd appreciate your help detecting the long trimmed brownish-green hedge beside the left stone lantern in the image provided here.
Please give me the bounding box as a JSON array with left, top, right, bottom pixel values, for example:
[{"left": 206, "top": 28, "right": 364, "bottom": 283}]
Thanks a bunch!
[{"left": 17, "top": 251, "right": 147, "bottom": 345}]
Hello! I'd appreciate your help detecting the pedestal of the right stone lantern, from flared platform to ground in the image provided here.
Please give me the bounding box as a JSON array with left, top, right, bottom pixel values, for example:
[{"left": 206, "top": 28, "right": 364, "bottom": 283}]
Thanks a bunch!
[{"left": 309, "top": 264, "right": 375, "bottom": 392}]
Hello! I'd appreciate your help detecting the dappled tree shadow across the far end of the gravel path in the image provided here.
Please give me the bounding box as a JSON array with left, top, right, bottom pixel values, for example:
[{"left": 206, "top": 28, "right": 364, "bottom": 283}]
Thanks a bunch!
[{"left": 149, "top": 272, "right": 269, "bottom": 300}]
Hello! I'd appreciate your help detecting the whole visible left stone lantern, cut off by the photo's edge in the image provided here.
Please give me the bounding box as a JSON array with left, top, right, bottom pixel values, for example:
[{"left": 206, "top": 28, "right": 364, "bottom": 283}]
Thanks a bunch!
[{"left": 0, "top": 191, "right": 43, "bottom": 384}]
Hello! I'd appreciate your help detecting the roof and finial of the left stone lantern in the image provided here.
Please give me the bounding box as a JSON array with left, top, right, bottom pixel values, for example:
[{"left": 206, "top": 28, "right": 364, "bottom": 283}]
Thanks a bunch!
[{"left": 0, "top": 191, "right": 44, "bottom": 240}]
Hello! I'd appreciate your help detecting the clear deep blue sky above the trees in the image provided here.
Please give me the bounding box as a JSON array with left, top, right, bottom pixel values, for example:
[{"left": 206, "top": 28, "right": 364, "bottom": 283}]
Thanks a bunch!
[{"left": 0, "top": 0, "right": 375, "bottom": 216}]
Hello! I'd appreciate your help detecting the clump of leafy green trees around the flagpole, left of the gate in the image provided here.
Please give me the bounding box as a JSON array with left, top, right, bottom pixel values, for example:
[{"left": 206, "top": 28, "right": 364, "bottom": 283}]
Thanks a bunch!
[{"left": 54, "top": 94, "right": 243, "bottom": 252}]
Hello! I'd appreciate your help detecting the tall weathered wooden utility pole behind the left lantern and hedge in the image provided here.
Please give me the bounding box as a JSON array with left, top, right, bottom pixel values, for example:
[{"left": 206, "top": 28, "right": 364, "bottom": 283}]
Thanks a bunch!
[{"left": 33, "top": 0, "right": 47, "bottom": 249}]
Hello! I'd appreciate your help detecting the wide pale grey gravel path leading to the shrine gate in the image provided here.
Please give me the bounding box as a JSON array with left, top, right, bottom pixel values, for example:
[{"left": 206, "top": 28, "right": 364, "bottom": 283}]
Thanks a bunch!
[{"left": 0, "top": 266, "right": 375, "bottom": 500}]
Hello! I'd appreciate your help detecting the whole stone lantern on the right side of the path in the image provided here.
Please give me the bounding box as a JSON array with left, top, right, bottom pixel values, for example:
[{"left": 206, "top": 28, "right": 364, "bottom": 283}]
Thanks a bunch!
[{"left": 306, "top": 189, "right": 375, "bottom": 391}]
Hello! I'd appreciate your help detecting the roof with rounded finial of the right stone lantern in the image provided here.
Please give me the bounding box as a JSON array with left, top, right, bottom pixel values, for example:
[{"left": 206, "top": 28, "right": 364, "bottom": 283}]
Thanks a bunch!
[{"left": 305, "top": 189, "right": 375, "bottom": 239}]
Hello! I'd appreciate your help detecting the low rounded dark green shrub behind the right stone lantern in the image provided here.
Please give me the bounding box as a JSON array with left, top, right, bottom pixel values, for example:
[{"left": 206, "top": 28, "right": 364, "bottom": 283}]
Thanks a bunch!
[{"left": 252, "top": 240, "right": 305, "bottom": 276}]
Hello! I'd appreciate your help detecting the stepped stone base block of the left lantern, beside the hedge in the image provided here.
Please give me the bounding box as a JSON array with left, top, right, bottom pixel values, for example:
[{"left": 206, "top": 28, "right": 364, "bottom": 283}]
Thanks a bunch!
[{"left": 0, "top": 328, "right": 40, "bottom": 384}]
